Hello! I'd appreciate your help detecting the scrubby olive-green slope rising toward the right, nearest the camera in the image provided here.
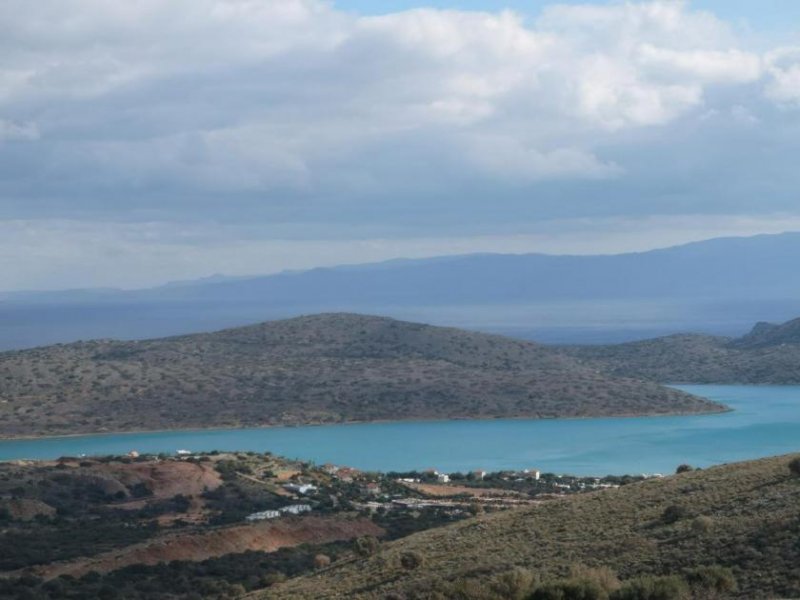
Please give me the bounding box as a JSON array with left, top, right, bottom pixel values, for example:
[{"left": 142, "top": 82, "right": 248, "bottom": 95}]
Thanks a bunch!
[{"left": 268, "top": 455, "right": 800, "bottom": 600}]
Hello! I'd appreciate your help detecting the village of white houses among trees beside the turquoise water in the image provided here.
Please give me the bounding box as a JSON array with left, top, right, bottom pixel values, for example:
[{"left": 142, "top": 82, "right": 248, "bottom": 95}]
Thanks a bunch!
[{"left": 189, "top": 453, "right": 647, "bottom": 522}]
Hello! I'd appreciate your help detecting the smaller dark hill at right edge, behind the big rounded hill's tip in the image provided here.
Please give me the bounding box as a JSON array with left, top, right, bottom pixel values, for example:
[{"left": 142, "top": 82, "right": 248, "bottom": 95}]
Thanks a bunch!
[{"left": 565, "top": 319, "right": 800, "bottom": 384}]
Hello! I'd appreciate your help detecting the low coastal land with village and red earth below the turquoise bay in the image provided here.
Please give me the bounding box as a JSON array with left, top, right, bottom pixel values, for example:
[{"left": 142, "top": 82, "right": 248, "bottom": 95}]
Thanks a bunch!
[{"left": 0, "top": 449, "right": 676, "bottom": 593}]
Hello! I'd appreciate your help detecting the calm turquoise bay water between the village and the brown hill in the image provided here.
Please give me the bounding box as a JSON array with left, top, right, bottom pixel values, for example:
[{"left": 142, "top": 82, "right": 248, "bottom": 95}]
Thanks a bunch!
[{"left": 0, "top": 385, "right": 800, "bottom": 475}]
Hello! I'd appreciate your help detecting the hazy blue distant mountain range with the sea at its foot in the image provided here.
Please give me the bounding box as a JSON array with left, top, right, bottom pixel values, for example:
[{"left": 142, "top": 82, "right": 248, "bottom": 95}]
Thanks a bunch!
[{"left": 0, "top": 233, "right": 800, "bottom": 349}]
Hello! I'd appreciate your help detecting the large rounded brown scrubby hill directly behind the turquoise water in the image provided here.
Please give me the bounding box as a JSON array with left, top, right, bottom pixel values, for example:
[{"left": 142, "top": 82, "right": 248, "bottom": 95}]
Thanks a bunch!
[{"left": 0, "top": 314, "right": 723, "bottom": 436}]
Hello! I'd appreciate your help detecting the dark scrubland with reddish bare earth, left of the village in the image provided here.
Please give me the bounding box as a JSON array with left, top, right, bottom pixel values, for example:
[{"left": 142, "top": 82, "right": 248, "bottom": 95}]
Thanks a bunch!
[{"left": 0, "top": 452, "right": 396, "bottom": 600}]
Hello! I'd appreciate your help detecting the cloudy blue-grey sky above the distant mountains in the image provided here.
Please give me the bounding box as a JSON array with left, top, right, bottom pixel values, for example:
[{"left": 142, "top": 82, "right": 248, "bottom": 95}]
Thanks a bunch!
[{"left": 0, "top": 0, "right": 800, "bottom": 290}]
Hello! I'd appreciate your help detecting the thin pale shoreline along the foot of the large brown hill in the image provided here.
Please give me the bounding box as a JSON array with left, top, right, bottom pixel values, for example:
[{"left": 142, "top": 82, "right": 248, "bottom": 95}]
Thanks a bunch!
[{"left": 0, "top": 400, "right": 735, "bottom": 442}]
